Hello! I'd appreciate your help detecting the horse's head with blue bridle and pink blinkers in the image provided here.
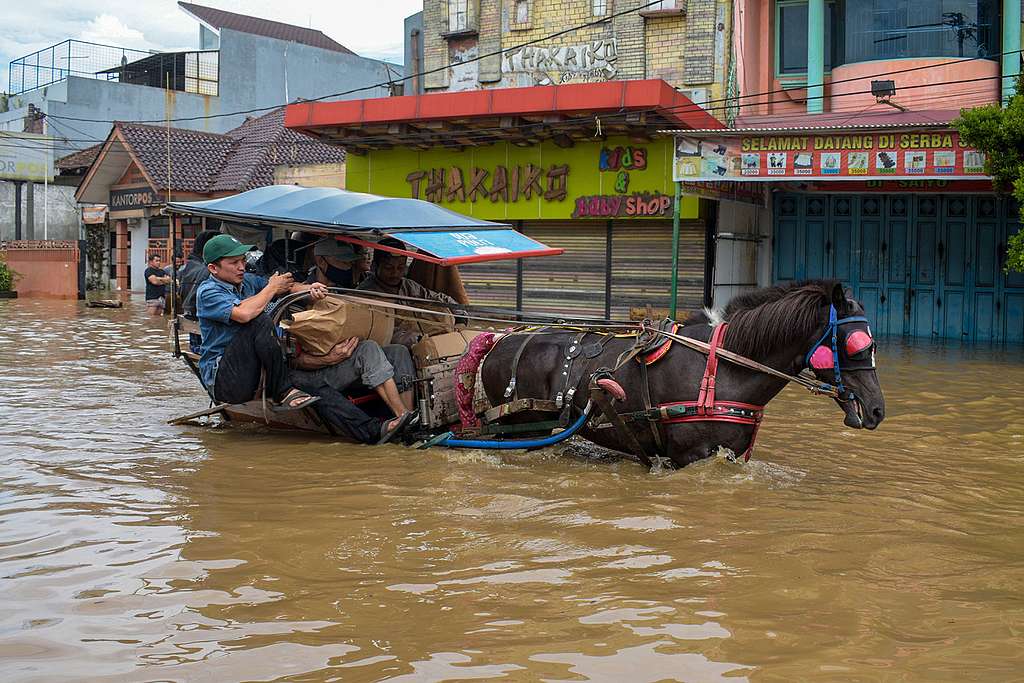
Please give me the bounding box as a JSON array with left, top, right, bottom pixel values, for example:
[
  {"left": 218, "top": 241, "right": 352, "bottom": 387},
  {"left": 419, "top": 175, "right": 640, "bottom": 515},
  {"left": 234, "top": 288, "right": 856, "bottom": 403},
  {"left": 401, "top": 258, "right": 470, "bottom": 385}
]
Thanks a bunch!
[{"left": 803, "top": 283, "right": 886, "bottom": 429}]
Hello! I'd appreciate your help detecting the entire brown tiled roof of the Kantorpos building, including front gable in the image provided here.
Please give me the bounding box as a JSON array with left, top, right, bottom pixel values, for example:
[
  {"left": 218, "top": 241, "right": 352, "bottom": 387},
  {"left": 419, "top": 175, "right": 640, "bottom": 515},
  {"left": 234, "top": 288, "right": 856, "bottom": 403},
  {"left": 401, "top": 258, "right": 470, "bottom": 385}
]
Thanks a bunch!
[{"left": 109, "top": 108, "right": 345, "bottom": 194}]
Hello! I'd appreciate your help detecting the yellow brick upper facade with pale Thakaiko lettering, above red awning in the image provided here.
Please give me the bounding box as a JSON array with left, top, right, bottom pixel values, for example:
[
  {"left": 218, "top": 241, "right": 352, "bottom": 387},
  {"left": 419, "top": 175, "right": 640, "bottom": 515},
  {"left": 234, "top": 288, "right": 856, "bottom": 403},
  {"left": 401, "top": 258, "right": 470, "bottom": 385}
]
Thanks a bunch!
[{"left": 415, "top": 0, "right": 735, "bottom": 116}]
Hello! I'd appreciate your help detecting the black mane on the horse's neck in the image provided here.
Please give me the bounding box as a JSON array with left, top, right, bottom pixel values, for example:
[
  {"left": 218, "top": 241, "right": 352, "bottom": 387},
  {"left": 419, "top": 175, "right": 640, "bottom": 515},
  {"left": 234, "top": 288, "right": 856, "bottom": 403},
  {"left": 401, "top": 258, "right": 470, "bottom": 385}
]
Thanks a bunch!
[{"left": 690, "top": 280, "right": 838, "bottom": 355}]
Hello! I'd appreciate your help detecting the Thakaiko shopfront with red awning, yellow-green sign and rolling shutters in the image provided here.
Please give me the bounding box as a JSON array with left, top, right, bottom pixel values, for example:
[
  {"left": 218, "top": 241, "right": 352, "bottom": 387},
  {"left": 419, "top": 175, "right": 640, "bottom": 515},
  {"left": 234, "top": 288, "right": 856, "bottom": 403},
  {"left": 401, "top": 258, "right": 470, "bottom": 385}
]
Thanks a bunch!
[{"left": 286, "top": 81, "right": 770, "bottom": 319}]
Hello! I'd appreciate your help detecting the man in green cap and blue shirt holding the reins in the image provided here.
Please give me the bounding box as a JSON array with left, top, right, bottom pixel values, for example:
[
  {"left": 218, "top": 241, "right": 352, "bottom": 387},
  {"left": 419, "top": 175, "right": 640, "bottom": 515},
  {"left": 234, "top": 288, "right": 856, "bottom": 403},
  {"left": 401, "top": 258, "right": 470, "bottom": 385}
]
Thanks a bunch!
[{"left": 196, "top": 234, "right": 327, "bottom": 411}]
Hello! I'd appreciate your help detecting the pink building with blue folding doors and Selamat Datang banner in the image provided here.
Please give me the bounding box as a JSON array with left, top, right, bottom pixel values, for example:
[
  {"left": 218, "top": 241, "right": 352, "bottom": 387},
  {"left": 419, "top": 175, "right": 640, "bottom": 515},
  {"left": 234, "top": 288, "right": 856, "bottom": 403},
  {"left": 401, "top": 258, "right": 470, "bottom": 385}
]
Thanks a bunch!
[{"left": 712, "top": 0, "right": 1024, "bottom": 342}]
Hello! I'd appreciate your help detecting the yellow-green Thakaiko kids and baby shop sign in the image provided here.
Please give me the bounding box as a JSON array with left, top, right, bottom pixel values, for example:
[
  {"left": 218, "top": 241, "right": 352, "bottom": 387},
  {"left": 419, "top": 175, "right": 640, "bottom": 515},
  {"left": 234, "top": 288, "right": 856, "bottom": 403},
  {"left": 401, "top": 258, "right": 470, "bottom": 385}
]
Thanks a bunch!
[{"left": 347, "top": 137, "right": 697, "bottom": 220}]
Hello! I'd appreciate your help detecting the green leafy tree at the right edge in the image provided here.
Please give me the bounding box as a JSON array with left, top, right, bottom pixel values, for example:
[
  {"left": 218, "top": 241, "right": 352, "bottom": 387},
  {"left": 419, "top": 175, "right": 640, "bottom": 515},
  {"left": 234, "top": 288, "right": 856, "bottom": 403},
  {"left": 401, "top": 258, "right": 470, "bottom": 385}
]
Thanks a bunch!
[{"left": 953, "top": 74, "right": 1024, "bottom": 272}]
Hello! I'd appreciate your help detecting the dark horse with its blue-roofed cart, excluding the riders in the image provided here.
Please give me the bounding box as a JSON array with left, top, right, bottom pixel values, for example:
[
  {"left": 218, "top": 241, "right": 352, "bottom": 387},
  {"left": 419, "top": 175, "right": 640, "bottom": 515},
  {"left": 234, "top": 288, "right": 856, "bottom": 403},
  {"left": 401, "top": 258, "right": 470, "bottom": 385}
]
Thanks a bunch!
[{"left": 166, "top": 186, "right": 884, "bottom": 466}]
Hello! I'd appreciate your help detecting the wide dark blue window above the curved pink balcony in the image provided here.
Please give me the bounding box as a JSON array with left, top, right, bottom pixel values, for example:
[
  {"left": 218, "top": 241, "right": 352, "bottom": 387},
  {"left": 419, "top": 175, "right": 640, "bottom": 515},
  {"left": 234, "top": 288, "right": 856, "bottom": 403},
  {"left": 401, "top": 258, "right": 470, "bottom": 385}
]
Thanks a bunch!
[{"left": 845, "top": 0, "right": 1000, "bottom": 62}]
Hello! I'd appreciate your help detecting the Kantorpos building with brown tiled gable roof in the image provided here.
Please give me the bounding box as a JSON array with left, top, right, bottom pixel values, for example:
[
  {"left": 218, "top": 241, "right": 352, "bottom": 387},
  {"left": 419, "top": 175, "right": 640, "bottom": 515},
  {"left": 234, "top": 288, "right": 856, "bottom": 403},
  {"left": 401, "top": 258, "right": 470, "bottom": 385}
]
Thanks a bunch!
[{"left": 76, "top": 109, "right": 345, "bottom": 290}]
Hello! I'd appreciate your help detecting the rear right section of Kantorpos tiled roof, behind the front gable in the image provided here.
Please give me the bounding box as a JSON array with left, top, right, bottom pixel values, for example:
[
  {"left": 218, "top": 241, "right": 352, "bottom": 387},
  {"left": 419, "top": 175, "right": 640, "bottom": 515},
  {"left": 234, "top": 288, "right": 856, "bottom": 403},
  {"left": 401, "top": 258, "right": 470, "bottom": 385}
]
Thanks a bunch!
[{"left": 211, "top": 108, "right": 345, "bottom": 191}]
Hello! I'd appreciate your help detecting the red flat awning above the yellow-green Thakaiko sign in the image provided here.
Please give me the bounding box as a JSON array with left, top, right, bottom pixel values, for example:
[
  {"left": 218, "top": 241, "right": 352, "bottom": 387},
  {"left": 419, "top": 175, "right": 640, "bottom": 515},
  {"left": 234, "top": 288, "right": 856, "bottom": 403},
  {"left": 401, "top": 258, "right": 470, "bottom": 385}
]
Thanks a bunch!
[{"left": 285, "top": 80, "right": 724, "bottom": 153}]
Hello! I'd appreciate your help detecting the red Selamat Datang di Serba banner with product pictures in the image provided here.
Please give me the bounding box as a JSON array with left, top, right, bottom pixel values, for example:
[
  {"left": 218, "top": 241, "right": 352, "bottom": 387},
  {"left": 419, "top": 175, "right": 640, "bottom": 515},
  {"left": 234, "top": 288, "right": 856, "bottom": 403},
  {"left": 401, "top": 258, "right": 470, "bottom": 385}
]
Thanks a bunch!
[{"left": 673, "top": 130, "right": 986, "bottom": 181}]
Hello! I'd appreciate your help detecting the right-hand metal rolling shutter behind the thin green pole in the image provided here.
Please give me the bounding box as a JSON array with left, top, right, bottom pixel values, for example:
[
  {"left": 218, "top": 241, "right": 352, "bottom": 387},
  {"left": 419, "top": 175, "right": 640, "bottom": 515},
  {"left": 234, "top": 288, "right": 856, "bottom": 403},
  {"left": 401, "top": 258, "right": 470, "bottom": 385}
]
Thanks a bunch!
[{"left": 611, "top": 220, "right": 705, "bottom": 319}]
